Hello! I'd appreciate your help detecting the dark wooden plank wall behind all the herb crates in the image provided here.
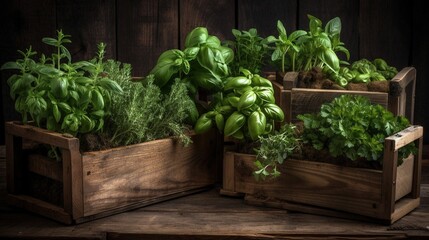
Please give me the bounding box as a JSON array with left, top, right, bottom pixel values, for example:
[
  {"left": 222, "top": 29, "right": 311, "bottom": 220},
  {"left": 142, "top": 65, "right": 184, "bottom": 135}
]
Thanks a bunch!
[{"left": 0, "top": 0, "right": 429, "bottom": 144}]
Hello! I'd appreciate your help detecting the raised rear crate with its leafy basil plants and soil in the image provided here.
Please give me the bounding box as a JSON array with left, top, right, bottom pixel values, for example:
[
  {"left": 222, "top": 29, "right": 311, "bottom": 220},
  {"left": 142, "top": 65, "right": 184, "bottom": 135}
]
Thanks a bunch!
[{"left": 267, "top": 15, "right": 416, "bottom": 122}]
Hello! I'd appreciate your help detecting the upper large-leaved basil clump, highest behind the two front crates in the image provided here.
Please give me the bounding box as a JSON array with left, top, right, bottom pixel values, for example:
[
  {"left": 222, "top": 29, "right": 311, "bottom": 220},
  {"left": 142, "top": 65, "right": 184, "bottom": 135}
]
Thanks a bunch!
[{"left": 150, "top": 27, "right": 234, "bottom": 95}]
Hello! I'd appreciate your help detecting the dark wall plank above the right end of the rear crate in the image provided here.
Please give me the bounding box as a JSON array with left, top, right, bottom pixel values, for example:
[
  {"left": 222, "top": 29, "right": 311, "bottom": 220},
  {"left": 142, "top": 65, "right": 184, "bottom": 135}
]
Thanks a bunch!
[{"left": 358, "top": 0, "right": 412, "bottom": 69}]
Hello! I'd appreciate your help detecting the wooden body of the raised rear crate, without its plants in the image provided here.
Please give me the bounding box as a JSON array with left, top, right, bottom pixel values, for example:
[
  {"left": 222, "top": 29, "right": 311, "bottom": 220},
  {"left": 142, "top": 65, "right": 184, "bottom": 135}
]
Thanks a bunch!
[{"left": 267, "top": 67, "right": 416, "bottom": 123}]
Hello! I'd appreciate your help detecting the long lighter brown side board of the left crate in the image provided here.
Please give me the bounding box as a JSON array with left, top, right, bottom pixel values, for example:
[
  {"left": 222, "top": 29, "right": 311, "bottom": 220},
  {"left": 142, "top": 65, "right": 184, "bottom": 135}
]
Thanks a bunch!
[{"left": 82, "top": 131, "right": 216, "bottom": 216}]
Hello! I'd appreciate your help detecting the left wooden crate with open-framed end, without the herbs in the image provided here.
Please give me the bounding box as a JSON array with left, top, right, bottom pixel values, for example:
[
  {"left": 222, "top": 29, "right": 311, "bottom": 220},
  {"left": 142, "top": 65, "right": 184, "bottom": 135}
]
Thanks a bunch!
[{"left": 6, "top": 122, "right": 222, "bottom": 224}]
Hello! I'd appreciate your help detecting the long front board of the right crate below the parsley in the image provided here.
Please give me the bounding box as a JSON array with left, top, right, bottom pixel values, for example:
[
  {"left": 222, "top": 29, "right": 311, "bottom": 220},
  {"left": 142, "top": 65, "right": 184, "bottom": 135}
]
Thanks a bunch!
[{"left": 234, "top": 153, "right": 381, "bottom": 216}]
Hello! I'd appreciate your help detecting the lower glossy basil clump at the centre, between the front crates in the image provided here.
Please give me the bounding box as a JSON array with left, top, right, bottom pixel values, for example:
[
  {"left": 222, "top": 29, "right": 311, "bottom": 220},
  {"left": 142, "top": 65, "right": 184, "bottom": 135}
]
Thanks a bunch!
[{"left": 194, "top": 69, "right": 284, "bottom": 141}]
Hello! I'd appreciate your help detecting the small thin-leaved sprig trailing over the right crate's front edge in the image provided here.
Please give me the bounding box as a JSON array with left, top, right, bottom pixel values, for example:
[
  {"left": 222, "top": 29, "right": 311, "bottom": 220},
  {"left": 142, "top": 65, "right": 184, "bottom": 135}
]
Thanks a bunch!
[{"left": 254, "top": 124, "right": 301, "bottom": 179}]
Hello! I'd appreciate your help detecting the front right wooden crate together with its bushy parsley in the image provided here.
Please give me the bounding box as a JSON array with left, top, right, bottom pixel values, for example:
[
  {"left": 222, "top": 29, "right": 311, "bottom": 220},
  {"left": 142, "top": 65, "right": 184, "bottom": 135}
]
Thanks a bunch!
[{"left": 222, "top": 95, "right": 423, "bottom": 224}]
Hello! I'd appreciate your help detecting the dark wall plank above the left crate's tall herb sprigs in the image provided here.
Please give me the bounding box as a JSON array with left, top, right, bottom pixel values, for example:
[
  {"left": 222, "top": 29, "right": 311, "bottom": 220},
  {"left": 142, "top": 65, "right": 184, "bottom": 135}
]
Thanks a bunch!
[{"left": 56, "top": 0, "right": 116, "bottom": 61}]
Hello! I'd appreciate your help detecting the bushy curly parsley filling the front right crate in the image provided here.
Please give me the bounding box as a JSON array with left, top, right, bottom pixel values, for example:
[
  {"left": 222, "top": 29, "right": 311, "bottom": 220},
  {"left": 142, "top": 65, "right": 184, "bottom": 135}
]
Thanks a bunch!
[{"left": 297, "top": 94, "right": 416, "bottom": 164}]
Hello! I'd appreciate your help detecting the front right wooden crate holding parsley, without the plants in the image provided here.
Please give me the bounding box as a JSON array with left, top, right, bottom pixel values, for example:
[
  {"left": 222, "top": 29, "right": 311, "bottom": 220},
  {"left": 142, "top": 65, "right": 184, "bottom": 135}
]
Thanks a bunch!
[{"left": 221, "top": 126, "right": 423, "bottom": 224}]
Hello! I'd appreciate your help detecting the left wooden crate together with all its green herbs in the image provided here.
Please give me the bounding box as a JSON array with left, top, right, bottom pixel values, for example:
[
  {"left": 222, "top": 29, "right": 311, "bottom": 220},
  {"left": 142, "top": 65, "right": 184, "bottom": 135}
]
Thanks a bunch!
[{"left": 2, "top": 31, "right": 218, "bottom": 224}]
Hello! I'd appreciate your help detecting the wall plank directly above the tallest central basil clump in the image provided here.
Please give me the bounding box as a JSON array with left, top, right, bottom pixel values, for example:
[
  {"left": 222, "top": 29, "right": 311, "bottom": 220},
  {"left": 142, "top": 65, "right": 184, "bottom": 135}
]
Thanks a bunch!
[{"left": 179, "top": 0, "right": 236, "bottom": 48}]
